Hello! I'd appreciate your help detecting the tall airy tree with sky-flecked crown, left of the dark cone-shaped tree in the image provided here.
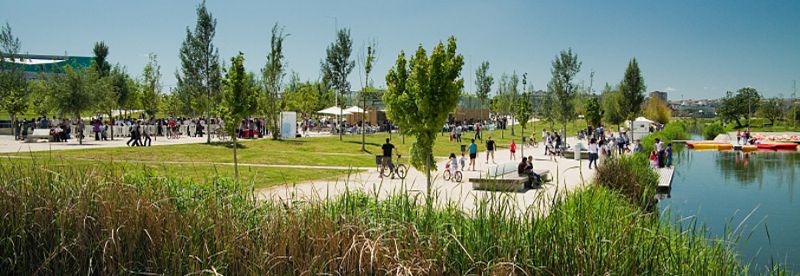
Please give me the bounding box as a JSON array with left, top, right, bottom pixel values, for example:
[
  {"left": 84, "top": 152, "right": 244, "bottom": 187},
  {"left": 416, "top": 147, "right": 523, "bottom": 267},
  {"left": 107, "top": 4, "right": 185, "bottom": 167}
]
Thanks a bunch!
[{"left": 547, "top": 49, "right": 581, "bottom": 137}]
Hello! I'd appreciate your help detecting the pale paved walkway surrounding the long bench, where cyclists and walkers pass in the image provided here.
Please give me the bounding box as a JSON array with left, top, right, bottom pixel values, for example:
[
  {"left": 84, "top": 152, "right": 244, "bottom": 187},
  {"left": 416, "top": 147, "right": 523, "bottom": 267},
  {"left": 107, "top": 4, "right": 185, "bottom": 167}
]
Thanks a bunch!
[{"left": 257, "top": 138, "right": 594, "bottom": 217}]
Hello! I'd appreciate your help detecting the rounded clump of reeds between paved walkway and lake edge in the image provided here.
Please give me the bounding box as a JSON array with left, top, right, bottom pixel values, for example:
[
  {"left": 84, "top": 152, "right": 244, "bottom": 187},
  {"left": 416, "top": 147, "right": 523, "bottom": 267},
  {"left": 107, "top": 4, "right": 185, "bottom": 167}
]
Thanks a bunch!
[{"left": 594, "top": 154, "right": 658, "bottom": 207}]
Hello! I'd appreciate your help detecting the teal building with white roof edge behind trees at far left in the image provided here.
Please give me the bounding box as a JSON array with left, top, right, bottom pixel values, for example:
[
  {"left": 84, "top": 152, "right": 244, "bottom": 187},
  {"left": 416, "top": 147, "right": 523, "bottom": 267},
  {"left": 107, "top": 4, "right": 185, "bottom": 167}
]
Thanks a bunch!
[{"left": 3, "top": 55, "right": 94, "bottom": 79}]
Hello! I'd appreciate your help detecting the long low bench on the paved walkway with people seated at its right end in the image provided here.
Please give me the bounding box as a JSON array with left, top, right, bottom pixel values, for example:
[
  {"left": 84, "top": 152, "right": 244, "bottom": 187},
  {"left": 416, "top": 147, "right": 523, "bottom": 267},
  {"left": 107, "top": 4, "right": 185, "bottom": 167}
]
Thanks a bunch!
[{"left": 469, "top": 162, "right": 550, "bottom": 192}]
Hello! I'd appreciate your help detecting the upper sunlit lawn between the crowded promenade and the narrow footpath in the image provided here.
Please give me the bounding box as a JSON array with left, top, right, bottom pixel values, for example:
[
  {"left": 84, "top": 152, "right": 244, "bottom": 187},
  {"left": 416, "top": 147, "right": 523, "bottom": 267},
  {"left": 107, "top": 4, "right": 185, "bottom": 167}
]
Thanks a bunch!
[{"left": 3, "top": 118, "right": 585, "bottom": 167}]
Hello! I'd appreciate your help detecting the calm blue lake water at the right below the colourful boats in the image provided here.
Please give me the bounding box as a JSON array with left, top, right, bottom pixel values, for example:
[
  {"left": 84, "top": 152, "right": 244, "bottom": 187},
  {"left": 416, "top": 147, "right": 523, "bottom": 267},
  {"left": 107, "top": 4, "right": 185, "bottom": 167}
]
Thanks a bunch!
[{"left": 659, "top": 146, "right": 800, "bottom": 272}]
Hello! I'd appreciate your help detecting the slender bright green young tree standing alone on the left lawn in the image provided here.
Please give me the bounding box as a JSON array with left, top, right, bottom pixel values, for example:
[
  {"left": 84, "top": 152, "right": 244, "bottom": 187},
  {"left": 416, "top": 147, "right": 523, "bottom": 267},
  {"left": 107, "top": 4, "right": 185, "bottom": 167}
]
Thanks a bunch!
[{"left": 219, "top": 52, "right": 257, "bottom": 183}]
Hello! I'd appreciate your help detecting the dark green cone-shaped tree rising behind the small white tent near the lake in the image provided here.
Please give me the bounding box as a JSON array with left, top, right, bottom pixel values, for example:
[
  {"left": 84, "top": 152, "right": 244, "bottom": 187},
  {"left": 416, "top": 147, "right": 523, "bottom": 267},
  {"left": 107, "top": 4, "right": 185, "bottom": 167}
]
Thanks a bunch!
[{"left": 619, "top": 58, "right": 646, "bottom": 133}]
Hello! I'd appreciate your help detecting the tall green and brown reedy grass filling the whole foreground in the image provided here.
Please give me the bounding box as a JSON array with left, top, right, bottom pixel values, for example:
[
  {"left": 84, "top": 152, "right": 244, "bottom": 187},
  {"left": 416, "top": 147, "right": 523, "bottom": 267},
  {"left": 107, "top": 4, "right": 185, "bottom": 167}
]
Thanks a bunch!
[{"left": 0, "top": 163, "right": 780, "bottom": 275}]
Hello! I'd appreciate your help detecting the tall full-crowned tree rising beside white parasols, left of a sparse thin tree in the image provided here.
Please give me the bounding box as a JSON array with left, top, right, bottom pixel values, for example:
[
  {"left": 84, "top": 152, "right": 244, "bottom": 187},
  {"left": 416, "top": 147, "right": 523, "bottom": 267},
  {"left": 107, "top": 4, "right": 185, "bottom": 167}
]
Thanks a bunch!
[{"left": 321, "top": 29, "right": 355, "bottom": 141}]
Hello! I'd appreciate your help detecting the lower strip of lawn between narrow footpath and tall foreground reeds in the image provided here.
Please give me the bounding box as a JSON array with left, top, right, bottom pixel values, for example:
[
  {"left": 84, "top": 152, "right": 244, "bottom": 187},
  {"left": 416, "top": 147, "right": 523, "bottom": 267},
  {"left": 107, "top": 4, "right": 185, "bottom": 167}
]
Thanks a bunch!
[{"left": 0, "top": 158, "right": 358, "bottom": 188}]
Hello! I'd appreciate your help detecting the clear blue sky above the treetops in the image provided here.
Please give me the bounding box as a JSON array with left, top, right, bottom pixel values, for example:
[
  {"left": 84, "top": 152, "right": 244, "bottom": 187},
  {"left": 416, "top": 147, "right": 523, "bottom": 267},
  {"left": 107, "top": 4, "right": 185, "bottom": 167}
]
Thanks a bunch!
[{"left": 0, "top": 0, "right": 800, "bottom": 99}]
